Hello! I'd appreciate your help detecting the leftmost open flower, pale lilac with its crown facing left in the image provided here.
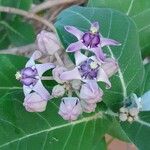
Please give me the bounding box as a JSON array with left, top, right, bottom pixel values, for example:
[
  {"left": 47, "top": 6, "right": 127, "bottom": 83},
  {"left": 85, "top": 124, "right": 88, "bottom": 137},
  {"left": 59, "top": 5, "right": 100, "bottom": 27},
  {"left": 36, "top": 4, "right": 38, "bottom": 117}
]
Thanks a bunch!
[{"left": 16, "top": 51, "right": 55, "bottom": 100}]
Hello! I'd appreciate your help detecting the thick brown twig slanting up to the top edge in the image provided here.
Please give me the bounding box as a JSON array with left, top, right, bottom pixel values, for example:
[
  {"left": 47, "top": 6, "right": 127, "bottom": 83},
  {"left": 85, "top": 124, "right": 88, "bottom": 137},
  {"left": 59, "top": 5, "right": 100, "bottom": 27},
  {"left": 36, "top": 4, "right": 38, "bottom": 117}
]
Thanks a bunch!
[{"left": 31, "top": 0, "right": 78, "bottom": 13}]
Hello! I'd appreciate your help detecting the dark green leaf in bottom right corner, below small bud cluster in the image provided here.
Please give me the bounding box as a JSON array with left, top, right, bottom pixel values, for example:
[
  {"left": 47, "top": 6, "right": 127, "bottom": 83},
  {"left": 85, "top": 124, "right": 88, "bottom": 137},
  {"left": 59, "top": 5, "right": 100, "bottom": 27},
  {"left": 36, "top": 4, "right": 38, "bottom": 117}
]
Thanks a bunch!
[{"left": 122, "top": 112, "right": 150, "bottom": 150}]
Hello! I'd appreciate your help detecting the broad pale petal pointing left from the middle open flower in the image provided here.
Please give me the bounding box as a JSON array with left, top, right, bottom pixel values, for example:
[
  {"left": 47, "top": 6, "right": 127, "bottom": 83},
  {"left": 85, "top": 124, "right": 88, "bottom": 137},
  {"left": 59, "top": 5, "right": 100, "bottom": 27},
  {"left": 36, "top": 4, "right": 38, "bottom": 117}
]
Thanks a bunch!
[{"left": 60, "top": 67, "right": 81, "bottom": 80}]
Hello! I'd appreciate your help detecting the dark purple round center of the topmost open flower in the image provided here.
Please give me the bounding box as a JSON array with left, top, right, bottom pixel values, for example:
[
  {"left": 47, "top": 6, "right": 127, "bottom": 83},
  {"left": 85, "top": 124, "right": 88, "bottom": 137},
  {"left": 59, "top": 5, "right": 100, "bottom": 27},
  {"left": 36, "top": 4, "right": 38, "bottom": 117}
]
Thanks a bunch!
[{"left": 82, "top": 31, "right": 100, "bottom": 48}]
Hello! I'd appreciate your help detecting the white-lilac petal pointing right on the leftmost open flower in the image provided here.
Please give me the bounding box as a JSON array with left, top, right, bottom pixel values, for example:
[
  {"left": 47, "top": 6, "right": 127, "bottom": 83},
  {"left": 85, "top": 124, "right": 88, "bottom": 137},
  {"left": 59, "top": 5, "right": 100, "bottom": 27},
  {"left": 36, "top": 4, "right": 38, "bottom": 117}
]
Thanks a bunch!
[{"left": 35, "top": 63, "right": 55, "bottom": 77}]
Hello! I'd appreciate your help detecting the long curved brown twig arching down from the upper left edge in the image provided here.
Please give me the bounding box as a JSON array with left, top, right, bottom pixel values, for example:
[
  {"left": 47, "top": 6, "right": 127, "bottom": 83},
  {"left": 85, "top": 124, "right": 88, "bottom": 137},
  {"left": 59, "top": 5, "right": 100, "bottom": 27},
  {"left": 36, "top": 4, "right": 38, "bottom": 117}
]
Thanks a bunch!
[{"left": 0, "top": 6, "right": 55, "bottom": 32}]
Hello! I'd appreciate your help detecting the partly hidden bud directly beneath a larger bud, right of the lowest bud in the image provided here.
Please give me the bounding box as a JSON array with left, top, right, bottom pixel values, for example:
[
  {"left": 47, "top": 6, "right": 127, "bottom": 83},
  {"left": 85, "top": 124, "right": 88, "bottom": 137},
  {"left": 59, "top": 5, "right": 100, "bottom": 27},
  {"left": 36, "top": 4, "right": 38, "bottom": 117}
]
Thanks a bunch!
[{"left": 81, "top": 100, "right": 96, "bottom": 113}]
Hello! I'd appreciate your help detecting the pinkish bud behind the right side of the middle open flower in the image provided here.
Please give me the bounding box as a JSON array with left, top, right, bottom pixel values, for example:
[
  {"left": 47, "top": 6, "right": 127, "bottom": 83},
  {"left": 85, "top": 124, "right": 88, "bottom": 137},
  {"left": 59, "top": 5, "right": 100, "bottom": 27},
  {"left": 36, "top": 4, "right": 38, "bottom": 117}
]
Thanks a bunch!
[{"left": 102, "top": 58, "right": 118, "bottom": 77}]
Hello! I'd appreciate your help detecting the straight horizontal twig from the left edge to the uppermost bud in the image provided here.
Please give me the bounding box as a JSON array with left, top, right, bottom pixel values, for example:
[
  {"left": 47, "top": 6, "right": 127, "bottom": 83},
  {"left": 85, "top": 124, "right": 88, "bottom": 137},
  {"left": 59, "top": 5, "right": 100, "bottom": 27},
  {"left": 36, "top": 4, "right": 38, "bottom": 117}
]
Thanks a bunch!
[{"left": 0, "top": 44, "right": 37, "bottom": 54}]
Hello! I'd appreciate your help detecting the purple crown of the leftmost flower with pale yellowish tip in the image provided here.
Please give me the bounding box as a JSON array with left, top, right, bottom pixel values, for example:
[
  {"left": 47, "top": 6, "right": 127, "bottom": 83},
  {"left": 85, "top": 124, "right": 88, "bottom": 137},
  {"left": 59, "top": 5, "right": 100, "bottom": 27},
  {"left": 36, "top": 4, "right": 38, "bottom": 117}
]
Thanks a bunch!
[{"left": 16, "top": 67, "right": 38, "bottom": 86}]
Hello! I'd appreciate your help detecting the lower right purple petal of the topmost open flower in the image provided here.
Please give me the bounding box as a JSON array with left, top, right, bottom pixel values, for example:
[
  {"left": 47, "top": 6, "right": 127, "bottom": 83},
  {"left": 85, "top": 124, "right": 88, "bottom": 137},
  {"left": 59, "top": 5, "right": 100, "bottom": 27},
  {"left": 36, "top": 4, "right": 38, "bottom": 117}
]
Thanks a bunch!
[{"left": 89, "top": 46, "right": 106, "bottom": 62}]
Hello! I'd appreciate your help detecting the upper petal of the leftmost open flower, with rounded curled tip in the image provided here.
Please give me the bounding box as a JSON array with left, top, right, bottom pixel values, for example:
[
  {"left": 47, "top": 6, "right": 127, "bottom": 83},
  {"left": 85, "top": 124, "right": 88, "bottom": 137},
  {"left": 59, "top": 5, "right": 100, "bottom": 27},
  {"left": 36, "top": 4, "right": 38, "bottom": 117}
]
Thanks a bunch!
[{"left": 25, "top": 51, "right": 42, "bottom": 67}]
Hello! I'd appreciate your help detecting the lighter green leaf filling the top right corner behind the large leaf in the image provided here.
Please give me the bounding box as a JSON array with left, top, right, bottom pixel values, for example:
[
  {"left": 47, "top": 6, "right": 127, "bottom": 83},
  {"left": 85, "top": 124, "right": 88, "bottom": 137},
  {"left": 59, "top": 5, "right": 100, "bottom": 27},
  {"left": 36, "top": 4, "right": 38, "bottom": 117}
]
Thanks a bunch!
[{"left": 87, "top": 0, "right": 150, "bottom": 56}]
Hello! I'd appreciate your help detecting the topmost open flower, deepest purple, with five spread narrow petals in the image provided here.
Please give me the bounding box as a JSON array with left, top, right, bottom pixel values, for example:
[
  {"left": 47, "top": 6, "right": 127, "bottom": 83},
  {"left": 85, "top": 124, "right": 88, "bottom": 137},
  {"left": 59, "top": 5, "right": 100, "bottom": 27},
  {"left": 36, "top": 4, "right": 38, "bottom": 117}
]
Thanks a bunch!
[{"left": 65, "top": 22, "right": 120, "bottom": 60}]
